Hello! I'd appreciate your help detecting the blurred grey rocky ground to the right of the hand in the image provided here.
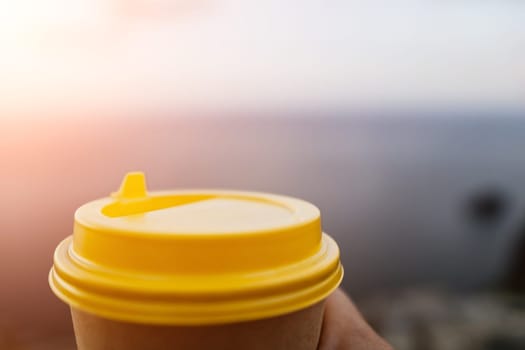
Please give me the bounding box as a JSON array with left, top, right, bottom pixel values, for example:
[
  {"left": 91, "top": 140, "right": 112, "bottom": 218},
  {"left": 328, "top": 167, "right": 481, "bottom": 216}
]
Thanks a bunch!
[{"left": 358, "top": 289, "right": 525, "bottom": 350}]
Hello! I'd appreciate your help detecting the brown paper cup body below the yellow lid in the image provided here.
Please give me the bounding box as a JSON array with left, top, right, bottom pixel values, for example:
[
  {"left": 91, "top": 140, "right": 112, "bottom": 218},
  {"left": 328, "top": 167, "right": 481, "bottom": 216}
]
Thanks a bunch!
[{"left": 71, "top": 303, "right": 324, "bottom": 350}]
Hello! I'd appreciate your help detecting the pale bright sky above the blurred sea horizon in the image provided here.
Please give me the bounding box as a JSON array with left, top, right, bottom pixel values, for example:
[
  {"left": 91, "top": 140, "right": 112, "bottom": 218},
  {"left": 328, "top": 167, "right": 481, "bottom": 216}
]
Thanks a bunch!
[{"left": 0, "top": 0, "right": 525, "bottom": 117}]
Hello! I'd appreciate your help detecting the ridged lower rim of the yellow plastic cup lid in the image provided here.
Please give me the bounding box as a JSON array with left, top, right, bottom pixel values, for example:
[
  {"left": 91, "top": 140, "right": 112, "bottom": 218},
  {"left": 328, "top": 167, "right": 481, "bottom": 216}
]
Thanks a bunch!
[{"left": 49, "top": 233, "right": 343, "bottom": 325}]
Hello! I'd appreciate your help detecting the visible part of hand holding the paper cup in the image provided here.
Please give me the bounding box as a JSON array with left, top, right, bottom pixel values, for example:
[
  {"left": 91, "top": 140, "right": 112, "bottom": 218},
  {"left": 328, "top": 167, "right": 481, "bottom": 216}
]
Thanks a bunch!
[{"left": 318, "top": 289, "right": 392, "bottom": 350}]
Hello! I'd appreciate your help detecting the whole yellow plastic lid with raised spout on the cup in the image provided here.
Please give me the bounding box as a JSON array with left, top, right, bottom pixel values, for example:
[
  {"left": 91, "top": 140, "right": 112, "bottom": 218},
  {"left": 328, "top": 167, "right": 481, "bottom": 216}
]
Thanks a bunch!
[{"left": 49, "top": 173, "right": 343, "bottom": 325}]
